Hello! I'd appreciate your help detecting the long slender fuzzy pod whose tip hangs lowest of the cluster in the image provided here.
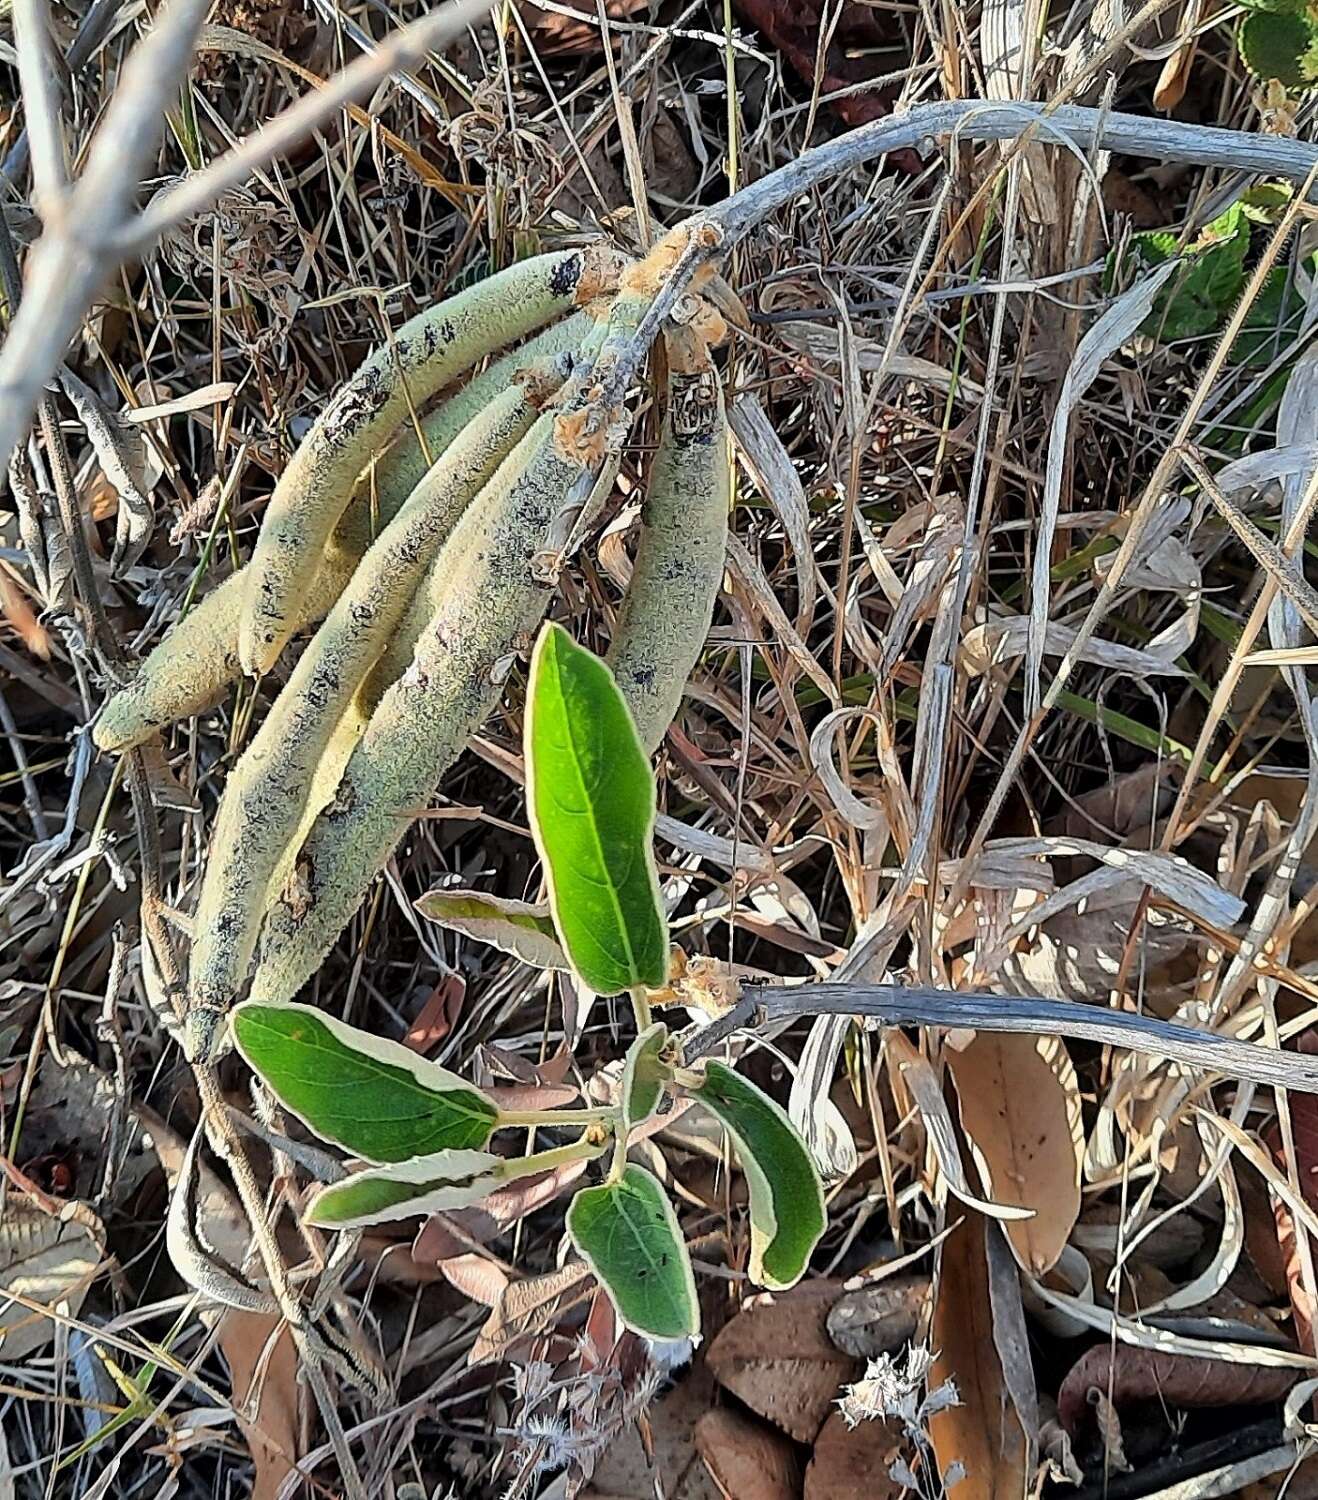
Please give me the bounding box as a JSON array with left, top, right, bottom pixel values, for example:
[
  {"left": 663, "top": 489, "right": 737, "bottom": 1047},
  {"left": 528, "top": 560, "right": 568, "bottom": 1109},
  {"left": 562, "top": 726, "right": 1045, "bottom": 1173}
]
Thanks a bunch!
[{"left": 187, "top": 386, "right": 537, "bottom": 1032}]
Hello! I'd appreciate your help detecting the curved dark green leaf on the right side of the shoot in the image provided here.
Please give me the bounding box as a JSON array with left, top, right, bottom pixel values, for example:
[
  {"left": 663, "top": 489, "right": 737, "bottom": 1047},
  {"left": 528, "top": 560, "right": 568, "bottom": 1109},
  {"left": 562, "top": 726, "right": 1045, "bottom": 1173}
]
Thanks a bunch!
[{"left": 690, "top": 1062, "right": 828, "bottom": 1289}]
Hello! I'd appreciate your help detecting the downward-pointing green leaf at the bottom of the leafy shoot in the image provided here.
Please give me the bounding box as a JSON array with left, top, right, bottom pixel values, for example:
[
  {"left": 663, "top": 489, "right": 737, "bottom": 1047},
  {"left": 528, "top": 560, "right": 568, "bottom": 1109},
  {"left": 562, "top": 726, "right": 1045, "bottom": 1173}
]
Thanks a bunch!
[{"left": 567, "top": 1166, "right": 700, "bottom": 1338}]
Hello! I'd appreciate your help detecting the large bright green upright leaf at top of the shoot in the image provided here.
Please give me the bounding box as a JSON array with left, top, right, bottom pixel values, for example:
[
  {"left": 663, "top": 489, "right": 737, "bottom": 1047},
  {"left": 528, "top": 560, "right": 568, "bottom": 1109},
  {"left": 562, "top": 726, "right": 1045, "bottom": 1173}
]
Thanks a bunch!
[{"left": 526, "top": 624, "right": 669, "bottom": 995}]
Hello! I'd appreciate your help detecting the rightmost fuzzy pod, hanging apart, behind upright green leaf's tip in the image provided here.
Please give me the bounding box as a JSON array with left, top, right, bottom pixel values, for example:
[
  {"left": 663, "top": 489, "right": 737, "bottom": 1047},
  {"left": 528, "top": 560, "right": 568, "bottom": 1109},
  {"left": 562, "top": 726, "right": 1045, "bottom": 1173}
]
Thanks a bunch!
[{"left": 604, "top": 338, "right": 732, "bottom": 755}]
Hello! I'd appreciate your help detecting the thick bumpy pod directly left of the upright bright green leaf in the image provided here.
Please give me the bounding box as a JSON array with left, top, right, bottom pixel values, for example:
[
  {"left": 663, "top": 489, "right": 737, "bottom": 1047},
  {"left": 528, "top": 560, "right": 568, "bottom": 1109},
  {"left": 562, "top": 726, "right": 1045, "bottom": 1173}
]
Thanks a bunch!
[{"left": 250, "top": 413, "right": 589, "bottom": 1002}]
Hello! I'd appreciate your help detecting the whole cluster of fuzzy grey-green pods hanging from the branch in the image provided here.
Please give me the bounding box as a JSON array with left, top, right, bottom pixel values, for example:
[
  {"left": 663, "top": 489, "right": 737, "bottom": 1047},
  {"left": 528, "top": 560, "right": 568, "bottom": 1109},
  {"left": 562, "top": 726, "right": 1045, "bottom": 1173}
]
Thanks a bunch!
[{"left": 93, "top": 228, "right": 730, "bottom": 1059}]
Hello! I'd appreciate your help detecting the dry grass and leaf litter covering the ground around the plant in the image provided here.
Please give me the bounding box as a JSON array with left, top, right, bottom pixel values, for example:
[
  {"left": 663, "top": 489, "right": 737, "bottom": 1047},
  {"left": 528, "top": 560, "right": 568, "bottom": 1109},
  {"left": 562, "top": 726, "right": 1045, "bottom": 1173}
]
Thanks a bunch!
[{"left": 10, "top": 0, "right": 1318, "bottom": 1500}]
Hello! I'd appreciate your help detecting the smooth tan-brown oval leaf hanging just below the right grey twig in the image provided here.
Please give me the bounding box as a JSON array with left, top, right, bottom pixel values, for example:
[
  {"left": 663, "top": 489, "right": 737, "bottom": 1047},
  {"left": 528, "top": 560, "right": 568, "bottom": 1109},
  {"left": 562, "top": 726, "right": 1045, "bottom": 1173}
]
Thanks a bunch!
[{"left": 943, "top": 1032, "right": 1084, "bottom": 1277}]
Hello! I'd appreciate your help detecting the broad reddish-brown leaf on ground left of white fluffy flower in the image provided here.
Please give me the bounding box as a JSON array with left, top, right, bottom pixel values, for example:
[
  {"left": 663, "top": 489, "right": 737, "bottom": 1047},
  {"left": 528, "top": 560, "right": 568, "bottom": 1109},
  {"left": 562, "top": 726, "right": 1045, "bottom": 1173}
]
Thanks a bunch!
[{"left": 705, "top": 1281, "right": 859, "bottom": 1443}]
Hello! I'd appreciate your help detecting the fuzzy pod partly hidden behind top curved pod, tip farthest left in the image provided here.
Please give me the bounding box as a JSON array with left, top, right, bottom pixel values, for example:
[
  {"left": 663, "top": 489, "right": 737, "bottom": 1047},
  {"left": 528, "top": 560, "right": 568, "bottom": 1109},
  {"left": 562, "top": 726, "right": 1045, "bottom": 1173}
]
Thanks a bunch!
[{"left": 100, "top": 330, "right": 595, "bottom": 752}]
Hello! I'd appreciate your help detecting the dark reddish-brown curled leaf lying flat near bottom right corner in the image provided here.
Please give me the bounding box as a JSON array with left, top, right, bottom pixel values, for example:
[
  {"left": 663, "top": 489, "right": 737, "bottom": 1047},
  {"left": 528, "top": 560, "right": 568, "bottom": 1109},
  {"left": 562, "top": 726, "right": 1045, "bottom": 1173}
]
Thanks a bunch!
[{"left": 1057, "top": 1344, "right": 1302, "bottom": 1434}]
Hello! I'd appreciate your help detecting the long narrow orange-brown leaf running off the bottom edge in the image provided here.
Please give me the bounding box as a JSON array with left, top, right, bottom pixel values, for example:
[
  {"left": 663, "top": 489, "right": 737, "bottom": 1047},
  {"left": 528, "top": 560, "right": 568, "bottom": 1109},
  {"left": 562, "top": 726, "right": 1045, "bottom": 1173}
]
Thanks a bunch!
[{"left": 928, "top": 1214, "right": 1029, "bottom": 1500}]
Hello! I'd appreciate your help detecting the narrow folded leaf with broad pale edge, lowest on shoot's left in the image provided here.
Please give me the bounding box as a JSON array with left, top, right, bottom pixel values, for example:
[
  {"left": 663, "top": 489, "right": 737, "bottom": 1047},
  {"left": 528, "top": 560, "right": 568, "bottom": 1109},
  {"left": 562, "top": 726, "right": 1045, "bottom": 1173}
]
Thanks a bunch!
[{"left": 303, "top": 1151, "right": 508, "bottom": 1229}]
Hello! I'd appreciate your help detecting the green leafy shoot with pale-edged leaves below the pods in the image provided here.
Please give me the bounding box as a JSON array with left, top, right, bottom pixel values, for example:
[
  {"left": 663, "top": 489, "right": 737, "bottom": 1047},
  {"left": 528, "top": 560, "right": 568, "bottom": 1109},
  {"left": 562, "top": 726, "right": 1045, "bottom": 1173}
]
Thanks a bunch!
[{"left": 232, "top": 626, "right": 826, "bottom": 1340}]
